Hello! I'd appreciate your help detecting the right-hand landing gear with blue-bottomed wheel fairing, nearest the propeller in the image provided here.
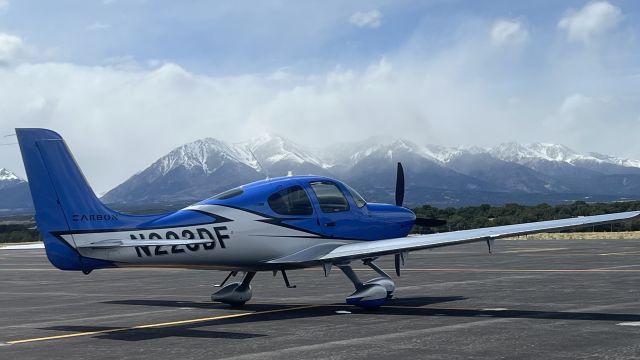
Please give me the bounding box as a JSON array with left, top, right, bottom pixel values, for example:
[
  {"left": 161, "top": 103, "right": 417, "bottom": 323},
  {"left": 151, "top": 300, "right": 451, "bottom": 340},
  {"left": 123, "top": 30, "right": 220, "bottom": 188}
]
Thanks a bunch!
[{"left": 337, "top": 259, "right": 395, "bottom": 309}]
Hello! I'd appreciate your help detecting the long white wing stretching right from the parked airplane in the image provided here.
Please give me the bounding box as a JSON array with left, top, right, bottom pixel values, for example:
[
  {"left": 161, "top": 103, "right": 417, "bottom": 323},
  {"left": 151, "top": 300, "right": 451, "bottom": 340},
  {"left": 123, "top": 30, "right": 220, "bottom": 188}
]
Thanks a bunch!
[{"left": 269, "top": 211, "right": 640, "bottom": 264}]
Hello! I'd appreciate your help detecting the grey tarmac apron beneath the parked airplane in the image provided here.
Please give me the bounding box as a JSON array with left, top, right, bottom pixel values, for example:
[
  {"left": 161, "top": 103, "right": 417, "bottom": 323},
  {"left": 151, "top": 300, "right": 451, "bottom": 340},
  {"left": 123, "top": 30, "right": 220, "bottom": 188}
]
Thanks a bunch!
[{"left": 0, "top": 239, "right": 640, "bottom": 360}]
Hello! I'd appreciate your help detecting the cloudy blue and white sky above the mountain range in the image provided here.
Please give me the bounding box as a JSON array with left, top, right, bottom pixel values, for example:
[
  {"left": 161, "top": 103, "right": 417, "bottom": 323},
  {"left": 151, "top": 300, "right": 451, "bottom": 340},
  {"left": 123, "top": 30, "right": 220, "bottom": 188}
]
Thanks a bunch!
[{"left": 0, "top": 0, "right": 640, "bottom": 192}]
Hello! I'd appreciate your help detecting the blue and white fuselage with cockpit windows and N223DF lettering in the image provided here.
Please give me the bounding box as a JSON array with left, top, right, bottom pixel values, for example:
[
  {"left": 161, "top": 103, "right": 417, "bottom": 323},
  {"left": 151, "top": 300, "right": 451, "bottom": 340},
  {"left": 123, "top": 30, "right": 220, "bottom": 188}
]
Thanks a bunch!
[{"left": 71, "top": 176, "right": 415, "bottom": 270}]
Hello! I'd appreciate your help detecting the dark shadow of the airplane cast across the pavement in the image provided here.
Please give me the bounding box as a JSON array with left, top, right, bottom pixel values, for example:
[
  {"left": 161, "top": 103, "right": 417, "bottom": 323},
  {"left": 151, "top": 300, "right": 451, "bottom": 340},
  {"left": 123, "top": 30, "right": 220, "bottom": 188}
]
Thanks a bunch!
[{"left": 43, "top": 296, "right": 640, "bottom": 341}]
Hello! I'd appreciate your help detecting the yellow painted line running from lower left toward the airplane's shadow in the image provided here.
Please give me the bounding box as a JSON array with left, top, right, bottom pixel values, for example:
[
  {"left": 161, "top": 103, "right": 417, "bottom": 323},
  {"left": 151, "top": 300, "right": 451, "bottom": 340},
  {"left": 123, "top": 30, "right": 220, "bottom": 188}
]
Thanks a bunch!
[{"left": 5, "top": 305, "right": 322, "bottom": 345}]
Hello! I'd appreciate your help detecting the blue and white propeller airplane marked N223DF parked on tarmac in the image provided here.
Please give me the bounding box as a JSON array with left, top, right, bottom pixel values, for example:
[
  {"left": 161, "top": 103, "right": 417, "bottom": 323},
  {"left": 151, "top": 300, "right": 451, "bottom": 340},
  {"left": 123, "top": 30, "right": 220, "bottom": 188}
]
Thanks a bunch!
[{"left": 16, "top": 128, "right": 640, "bottom": 309}]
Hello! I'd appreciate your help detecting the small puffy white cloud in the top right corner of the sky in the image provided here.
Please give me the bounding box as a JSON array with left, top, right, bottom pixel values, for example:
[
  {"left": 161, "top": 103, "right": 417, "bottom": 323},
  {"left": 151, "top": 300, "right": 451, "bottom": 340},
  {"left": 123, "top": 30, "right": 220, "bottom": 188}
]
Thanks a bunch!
[{"left": 558, "top": 1, "right": 622, "bottom": 44}]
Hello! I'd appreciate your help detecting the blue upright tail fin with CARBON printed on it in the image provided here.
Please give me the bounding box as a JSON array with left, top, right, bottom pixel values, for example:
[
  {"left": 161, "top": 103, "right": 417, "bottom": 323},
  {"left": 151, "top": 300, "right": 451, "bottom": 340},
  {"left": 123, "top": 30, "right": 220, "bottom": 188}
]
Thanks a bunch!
[{"left": 16, "top": 129, "right": 148, "bottom": 272}]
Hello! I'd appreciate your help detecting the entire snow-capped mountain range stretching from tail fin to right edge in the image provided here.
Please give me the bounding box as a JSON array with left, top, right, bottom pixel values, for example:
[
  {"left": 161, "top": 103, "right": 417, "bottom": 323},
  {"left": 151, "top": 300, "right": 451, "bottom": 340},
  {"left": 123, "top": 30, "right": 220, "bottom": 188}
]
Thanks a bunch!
[{"left": 96, "top": 134, "right": 640, "bottom": 205}]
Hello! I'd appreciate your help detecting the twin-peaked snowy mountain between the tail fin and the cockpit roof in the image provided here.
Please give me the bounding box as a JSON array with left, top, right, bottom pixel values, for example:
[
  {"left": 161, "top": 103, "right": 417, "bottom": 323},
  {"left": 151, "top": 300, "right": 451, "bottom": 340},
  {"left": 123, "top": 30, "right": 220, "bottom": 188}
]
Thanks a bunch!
[{"left": 102, "top": 134, "right": 327, "bottom": 203}]
